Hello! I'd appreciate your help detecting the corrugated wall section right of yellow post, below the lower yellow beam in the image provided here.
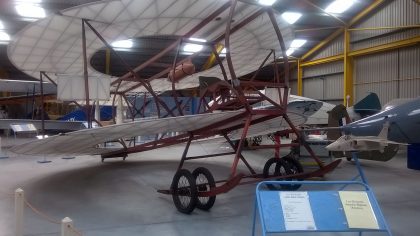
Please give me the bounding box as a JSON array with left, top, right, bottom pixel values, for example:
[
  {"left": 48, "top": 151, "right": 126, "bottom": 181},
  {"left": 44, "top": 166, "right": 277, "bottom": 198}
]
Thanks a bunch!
[{"left": 353, "top": 46, "right": 420, "bottom": 104}]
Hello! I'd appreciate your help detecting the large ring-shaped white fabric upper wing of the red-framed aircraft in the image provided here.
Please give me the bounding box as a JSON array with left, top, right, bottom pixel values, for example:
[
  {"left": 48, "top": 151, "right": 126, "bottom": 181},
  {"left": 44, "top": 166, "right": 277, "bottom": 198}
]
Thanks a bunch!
[{"left": 8, "top": 0, "right": 293, "bottom": 92}]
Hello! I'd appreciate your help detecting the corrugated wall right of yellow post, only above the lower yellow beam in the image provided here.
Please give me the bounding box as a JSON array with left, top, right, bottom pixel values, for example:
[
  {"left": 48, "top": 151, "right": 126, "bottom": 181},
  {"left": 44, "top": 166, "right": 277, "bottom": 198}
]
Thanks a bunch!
[{"left": 350, "top": 0, "right": 420, "bottom": 50}]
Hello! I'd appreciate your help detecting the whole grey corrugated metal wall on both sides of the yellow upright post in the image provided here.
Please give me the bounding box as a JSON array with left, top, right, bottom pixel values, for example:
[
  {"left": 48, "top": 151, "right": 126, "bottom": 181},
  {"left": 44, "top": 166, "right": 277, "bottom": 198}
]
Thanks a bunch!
[{"left": 296, "top": 0, "right": 420, "bottom": 104}]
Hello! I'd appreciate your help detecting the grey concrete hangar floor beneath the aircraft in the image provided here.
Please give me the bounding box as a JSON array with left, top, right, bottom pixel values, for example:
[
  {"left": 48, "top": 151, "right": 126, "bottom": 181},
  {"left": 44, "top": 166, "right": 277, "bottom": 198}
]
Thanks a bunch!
[{"left": 0, "top": 136, "right": 420, "bottom": 236}]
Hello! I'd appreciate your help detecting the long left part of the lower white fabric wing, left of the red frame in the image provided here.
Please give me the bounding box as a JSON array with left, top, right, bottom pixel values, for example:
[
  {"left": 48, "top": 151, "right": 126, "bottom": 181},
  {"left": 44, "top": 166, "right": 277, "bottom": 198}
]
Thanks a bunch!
[{"left": 11, "top": 111, "right": 243, "bottom": 155}]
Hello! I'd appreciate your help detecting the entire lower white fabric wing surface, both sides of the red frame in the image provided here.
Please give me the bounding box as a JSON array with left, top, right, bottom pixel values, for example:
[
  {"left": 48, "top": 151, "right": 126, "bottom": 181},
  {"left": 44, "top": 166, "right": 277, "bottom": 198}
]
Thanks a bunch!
[{"left": 11, "top": 109, "right": 306, "bottom": 155}]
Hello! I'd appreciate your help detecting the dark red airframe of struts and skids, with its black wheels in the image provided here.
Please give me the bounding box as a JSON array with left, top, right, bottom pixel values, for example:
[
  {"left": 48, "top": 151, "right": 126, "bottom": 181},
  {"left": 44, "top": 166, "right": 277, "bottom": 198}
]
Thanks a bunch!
[{"left": 59, "top": 0, "right": 340, "bottom": 213}]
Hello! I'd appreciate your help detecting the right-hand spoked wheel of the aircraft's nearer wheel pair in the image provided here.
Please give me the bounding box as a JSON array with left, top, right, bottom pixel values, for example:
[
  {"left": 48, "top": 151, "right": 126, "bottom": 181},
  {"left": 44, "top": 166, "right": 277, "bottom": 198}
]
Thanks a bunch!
[{"left": 192, "top": 167, "right": 216, "bottom": 211}]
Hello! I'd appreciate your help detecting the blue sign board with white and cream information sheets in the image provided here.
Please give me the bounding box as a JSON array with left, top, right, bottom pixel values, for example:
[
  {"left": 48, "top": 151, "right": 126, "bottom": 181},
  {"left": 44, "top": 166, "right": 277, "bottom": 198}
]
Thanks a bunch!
[{"left": 252, "top": 181, "right": 392, "bottom": 236}]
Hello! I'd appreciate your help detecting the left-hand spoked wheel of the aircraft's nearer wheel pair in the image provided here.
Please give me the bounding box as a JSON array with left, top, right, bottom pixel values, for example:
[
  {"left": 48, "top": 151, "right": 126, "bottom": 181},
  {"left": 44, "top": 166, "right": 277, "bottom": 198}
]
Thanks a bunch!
[{"left": 171, "top": 169, "right": 197, "bottom": 214}]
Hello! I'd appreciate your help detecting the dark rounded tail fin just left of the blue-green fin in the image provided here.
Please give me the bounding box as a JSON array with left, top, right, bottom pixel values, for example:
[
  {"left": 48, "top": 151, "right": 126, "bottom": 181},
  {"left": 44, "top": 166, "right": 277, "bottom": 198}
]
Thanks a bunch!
[{"left": 327, "top": 104, "right": 350, "bottom": 140}]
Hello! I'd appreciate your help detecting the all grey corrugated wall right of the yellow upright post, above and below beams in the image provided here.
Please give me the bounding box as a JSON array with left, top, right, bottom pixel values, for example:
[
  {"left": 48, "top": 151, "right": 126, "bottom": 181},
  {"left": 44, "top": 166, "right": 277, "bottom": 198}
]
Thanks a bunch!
[{"left": 350, "top": 0, "right": 420, "bottom": 104}]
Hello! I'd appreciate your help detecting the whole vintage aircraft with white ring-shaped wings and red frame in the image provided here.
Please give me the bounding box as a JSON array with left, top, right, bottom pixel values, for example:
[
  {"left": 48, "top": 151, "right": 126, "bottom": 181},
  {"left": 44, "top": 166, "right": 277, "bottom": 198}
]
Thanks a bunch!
[{"left": 8, "top": 0, "right": 341, "bottom": 213}]
